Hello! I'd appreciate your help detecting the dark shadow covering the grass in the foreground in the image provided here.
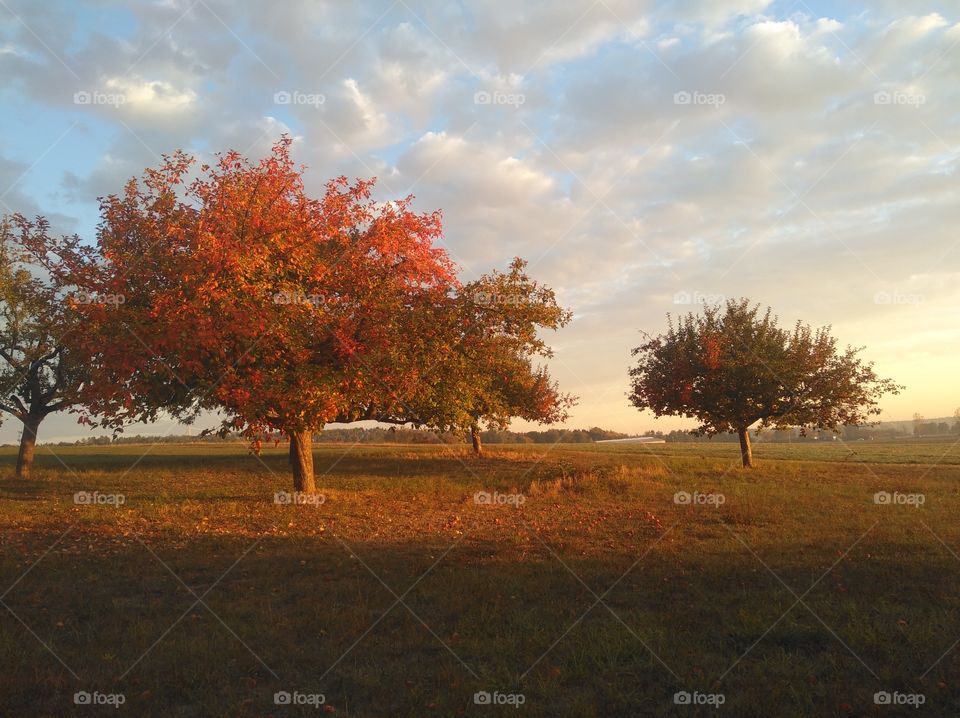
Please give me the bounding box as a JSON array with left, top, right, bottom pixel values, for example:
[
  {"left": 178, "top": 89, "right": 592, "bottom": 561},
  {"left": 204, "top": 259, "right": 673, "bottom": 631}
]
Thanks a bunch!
[{"left": 0, "top": 531, "right": 960, "bottom": 716}]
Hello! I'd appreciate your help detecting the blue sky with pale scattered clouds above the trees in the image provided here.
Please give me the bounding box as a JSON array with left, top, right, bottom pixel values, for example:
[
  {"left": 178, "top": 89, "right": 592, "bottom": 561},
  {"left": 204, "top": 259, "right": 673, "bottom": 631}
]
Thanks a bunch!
[{"left": 0, "top": 0, "right": 960, "bottom": 441}]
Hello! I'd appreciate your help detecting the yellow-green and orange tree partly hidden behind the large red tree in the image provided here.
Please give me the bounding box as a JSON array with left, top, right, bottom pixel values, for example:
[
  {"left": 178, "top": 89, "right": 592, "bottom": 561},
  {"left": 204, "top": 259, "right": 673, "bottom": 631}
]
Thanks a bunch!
[{"left": 410, "top": 258, "right": 575, "bottom": 455}]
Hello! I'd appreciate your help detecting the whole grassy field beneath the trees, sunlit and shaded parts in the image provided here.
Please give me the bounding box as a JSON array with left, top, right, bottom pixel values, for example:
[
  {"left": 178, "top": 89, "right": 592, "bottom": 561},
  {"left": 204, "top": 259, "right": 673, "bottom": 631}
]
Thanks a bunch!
[{"left": 0, "top": 441, "right": 960, "bottom": 716}]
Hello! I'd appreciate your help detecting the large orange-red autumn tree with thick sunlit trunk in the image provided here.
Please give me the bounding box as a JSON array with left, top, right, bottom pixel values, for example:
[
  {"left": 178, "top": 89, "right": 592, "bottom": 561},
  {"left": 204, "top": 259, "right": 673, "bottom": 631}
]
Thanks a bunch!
[{"left": 36, "top": 139, "right": 457, "bottom": 492}]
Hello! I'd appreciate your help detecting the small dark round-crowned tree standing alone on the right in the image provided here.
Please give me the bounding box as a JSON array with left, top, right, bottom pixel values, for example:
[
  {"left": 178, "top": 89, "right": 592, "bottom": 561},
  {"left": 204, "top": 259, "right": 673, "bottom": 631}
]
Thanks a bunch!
[{"left": 629, "top": 299, "right": 903, "bottom": 467}]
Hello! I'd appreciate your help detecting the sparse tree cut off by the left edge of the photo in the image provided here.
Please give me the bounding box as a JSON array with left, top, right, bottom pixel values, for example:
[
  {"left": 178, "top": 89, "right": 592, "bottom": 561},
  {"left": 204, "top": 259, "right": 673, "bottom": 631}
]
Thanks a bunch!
[{"left": 0, "top": 215, "right": 85, "bottom": 478}]
